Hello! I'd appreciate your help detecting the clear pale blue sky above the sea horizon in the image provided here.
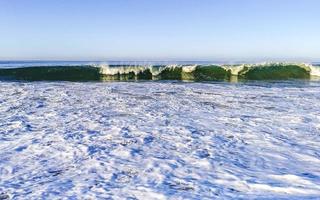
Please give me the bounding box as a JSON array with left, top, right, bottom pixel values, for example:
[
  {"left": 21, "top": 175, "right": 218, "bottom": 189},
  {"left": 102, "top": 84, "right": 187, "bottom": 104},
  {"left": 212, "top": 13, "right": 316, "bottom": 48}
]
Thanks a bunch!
[{"left": 0, "top": 0, "right": 320, "bottom": 61}]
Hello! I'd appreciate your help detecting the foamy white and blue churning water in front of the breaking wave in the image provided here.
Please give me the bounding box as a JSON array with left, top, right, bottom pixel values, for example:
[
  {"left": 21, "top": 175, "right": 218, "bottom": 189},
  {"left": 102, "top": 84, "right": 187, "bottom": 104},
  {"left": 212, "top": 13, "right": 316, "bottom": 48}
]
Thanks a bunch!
[{"left": 0, "top": 81, "right": 320, "bottom": 199}]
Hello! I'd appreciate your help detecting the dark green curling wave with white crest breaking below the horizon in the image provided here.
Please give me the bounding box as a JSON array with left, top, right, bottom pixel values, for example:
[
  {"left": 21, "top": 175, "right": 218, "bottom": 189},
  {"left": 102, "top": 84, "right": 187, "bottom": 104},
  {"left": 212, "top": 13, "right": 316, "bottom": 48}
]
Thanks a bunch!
[{"left": 0, "top": 63, "right": 320, "bottom": 81}]
